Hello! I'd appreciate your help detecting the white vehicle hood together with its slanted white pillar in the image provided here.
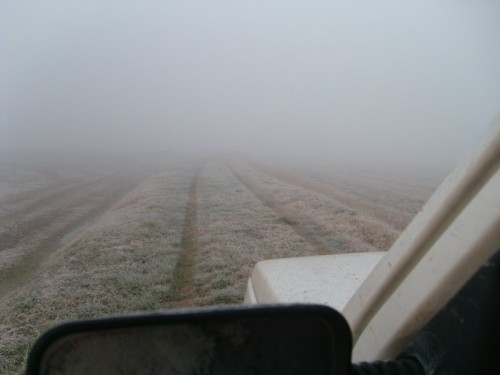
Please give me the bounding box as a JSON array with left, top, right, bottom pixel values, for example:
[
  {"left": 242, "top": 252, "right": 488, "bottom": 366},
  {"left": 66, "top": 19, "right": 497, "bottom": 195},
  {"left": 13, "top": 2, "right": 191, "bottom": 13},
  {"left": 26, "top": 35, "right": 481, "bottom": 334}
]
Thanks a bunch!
[{"left": 243, "top": 117, "right": 500, "bottom": 361}]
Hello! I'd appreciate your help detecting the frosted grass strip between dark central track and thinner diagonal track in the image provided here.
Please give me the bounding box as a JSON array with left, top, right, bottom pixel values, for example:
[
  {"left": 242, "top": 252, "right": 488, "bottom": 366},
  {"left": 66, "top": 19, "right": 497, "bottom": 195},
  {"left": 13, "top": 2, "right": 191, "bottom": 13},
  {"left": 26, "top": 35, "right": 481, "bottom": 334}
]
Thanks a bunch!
[{"left": 191, "top": 163, "right": 316, "bottom": 305}]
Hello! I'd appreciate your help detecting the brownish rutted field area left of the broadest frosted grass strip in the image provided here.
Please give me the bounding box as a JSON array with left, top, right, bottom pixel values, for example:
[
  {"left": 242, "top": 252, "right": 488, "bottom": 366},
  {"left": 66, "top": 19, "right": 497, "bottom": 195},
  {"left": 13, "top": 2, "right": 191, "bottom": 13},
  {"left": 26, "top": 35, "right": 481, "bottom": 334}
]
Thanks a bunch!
[{"left": 0, "top": 156, "right": 148, "bottom": 296}]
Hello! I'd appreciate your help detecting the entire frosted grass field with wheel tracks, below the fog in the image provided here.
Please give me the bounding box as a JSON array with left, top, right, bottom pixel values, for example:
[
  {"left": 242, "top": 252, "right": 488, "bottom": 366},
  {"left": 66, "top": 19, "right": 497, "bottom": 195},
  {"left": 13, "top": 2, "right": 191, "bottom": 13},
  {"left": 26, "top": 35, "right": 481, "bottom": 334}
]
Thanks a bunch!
[{"left": 0, "top": 159, "right": 443, "bottom": 373}]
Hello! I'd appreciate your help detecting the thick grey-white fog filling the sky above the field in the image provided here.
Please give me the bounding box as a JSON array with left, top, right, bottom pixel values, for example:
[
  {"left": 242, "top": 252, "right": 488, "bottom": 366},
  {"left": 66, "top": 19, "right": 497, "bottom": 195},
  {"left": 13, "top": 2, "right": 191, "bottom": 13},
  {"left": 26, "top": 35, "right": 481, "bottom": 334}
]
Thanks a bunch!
[{"left": 0, "top": 0, "right": 500, "bottom": 169}]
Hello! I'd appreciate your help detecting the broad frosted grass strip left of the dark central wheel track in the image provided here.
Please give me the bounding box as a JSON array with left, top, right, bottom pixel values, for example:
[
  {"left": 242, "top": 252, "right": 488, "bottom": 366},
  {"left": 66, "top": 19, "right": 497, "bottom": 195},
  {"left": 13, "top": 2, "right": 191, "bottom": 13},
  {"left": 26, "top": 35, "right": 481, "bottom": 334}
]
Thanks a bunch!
[{"left": 0, "top": 167, "right": 192, "bottom": 374}]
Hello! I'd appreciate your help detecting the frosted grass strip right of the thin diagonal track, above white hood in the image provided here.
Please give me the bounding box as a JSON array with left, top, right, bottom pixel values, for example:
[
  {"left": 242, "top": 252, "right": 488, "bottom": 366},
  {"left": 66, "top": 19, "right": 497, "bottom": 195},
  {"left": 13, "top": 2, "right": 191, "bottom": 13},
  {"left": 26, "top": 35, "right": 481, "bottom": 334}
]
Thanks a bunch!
[{"left": 232, "top": 164, "right": 399, "bottom": 254}]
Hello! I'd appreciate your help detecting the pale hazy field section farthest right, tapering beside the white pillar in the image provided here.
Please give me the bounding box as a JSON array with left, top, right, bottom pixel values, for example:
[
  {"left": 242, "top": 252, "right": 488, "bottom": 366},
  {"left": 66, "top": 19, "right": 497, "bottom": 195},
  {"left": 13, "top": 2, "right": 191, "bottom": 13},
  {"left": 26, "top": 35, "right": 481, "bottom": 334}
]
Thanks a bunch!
[{"left": 254, "top": 164, "right": 446, "bottom": 231}]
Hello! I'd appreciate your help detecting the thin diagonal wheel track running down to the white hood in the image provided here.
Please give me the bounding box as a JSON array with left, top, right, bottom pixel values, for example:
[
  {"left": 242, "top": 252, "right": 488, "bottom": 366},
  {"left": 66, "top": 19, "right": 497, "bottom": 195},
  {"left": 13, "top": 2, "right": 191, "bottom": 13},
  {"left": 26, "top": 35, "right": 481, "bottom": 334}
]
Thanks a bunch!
[{"left": 229, "top": 166, "right": 333, "bottom": 255}]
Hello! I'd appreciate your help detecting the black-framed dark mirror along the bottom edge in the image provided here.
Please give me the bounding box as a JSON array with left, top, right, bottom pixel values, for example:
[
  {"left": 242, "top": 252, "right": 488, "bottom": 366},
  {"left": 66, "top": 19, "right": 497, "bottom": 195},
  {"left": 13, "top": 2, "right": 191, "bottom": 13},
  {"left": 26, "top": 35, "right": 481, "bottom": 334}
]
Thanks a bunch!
[{"left": 27, "top": 305, "right": 352, "bottom": 375}]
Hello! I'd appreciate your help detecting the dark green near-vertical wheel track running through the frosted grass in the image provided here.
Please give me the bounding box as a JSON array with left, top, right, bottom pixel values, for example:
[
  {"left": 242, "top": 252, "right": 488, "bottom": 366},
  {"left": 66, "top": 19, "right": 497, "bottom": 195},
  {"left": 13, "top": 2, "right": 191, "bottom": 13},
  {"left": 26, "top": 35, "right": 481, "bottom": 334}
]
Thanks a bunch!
[{"left": 171, "top": 168, "right": 201, "bottom": 307}]
